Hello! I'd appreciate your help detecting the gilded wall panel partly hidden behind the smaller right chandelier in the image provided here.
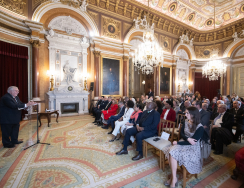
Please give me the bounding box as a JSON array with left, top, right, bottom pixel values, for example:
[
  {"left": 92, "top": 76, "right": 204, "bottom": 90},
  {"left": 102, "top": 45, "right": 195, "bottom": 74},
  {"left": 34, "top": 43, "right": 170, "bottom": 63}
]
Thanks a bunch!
[{"left": 195, "top": 44, "right": 222, "bottom": 59}]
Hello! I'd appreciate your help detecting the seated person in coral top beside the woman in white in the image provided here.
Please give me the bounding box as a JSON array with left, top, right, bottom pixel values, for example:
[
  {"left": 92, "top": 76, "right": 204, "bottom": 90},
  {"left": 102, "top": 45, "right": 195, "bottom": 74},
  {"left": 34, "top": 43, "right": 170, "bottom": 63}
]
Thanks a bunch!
[{"left": 121, "top": 104, "right": 142, "bottom": 143}]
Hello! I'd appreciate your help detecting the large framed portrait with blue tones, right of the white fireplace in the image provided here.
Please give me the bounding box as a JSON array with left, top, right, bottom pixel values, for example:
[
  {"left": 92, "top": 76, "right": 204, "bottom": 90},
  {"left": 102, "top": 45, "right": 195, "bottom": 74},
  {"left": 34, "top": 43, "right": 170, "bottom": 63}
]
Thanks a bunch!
[{"left": 102, "top": 58, "right": 121, "bottom": 95}]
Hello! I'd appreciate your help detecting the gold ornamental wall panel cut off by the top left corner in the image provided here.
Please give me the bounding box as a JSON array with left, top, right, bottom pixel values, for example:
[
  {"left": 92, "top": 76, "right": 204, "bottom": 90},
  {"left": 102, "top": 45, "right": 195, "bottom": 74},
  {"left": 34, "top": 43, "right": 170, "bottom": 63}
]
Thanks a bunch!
[{"left": 0, "top": 0, "right": 26, "bottom": 15}]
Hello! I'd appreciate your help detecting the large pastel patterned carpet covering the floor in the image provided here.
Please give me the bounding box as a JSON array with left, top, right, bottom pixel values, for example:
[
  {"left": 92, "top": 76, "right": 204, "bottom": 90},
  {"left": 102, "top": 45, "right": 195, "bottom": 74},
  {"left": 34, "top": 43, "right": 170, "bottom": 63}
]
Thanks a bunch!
[{"left": 0, "top": 115, "right": 244, "bottom": 188}]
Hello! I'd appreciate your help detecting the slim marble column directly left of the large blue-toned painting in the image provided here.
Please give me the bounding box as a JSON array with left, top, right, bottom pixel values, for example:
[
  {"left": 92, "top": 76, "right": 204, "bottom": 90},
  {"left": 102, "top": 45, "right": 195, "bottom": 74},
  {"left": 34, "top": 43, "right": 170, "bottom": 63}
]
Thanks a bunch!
[{"left": 93, "top": 51, "right": 101, "bottom": 97}]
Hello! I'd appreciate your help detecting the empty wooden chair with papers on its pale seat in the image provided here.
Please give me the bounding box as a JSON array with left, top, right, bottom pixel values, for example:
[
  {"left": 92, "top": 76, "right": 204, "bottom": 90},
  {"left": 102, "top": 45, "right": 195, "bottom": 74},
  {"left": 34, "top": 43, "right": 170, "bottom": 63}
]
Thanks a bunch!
[{"left": 143, "top": 119, "right": 175, "bottom": 171}]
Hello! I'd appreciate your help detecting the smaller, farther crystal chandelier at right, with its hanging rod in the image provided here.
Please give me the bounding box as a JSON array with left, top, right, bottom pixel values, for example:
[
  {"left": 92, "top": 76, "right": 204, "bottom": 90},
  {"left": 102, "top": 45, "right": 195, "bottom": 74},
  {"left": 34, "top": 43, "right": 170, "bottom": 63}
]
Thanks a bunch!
[{"left": 202, "top": 1, "right": 226, "bottom": 81}]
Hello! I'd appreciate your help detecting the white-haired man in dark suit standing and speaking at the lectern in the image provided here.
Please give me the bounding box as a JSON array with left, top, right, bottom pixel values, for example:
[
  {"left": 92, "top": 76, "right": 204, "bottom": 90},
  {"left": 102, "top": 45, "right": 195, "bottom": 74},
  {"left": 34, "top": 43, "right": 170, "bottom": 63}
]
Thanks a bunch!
[{"left": 0, "top": 86, "right": 35, "bottom": 148}]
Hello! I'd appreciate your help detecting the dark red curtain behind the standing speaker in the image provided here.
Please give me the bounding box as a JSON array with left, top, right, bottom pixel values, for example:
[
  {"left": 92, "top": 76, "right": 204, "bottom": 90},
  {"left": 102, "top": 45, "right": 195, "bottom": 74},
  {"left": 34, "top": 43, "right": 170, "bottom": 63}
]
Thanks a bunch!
[{"left": 0, "top": 41, "right": 28, "bottom": 102}]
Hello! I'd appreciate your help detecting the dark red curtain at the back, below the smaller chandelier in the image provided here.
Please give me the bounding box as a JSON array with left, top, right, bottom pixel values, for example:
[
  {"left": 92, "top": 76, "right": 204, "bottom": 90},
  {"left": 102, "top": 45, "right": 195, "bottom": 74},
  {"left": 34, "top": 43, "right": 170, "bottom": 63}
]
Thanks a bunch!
[{"left": 194, "top": 72, "right": 220, "bottom": 100}]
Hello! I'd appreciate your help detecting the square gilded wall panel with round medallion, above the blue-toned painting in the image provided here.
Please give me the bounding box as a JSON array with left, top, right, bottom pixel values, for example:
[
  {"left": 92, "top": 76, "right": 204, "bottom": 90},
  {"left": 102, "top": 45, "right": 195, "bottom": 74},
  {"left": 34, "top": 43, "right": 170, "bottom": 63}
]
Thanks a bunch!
[{"left": 102, "top": 16, "right": 121, "bottom": 40}]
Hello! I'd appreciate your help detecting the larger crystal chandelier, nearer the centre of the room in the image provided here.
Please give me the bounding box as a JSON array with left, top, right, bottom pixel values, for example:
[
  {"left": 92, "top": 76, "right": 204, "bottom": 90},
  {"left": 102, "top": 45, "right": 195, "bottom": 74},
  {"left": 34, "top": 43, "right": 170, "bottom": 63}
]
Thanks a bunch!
[{"left": 132, "top": 1, "right": 163, "bottom": 75}]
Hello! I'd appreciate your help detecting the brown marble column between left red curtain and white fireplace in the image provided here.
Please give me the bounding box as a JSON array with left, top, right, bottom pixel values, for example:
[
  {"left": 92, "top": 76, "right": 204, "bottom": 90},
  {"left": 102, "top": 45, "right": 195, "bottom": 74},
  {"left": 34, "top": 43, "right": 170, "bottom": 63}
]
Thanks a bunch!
[{"left": 30, "top": 39, "right": 41, "bottom": 101}]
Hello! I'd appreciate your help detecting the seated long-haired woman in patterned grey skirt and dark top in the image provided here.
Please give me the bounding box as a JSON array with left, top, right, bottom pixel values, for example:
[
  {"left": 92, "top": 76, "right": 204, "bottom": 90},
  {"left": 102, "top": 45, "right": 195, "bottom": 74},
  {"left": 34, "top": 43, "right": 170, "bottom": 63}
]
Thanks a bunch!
[{"left": 163, "top": 107, "right": 209, "bottom": 187}]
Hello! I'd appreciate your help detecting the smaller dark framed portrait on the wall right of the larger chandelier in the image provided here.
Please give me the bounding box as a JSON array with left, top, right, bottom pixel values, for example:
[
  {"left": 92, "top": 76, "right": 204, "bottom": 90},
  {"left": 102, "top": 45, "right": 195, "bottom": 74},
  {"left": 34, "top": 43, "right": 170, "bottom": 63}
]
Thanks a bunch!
[{"left": 160, "top": 67, "right": 171, "bottom": 95}]
